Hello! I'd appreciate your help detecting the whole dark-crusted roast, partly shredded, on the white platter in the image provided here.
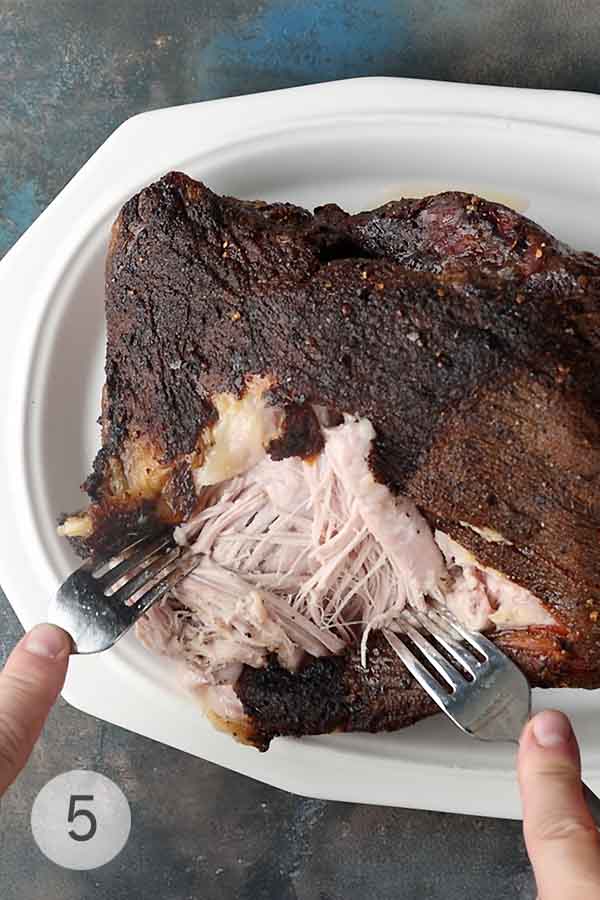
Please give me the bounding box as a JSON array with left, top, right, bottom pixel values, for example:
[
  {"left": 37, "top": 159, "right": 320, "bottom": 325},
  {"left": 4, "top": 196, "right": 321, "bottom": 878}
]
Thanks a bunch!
[{"left": 60, "top": 172, "right": 600, "bottom": 749}]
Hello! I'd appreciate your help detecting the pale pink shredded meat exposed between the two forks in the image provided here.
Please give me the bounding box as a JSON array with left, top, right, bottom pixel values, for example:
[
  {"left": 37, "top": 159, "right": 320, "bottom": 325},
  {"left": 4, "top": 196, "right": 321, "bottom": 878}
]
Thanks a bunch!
[{"left": 138, "top": 416, "right": 552, "bottom": 685}]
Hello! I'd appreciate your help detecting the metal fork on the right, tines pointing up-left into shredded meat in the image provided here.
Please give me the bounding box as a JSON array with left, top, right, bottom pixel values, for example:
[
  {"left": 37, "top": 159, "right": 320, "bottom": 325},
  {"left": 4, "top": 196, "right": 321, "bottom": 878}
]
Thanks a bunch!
[{"left": 384, "top": 607, "right": 600, "bottom": 826}]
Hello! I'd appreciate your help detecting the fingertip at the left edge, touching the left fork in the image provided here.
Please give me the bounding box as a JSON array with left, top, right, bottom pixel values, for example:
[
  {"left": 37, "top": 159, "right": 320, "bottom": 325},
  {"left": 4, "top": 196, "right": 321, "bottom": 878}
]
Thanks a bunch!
[{"left": 0, "top": 625, "right": 71, "bottom": 797}]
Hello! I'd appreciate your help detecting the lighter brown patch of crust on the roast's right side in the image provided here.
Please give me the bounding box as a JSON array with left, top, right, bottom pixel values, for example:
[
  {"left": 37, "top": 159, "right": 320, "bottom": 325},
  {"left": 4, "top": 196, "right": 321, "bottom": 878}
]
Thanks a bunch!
[{"left": 407, "top": 373, "right": 600, "bottom": 687}]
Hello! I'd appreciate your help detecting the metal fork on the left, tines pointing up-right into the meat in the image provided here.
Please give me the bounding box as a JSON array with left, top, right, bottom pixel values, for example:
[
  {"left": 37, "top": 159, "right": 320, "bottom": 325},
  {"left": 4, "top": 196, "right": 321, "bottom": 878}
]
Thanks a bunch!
[{"left": 48, "top": 530, "right": 199, "bottom": 653}]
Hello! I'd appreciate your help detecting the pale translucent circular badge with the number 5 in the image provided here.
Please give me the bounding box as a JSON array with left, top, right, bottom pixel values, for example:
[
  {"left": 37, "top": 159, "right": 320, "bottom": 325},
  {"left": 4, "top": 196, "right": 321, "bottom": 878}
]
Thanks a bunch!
[{"left": 31, "top": 769, "right": 131, "bottom": 869}]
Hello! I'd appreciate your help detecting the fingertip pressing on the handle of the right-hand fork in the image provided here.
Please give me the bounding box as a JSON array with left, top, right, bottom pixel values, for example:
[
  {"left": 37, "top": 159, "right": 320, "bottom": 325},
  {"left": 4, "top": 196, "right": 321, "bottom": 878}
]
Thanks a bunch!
[{"left": 519, "top": 710, "right": 600, "bottom": 900}]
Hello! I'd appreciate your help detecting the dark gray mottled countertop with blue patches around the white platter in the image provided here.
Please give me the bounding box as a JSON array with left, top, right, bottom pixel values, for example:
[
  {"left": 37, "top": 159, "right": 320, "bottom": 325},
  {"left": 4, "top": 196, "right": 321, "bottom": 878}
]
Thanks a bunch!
[{"left": 0, "top": 0, "right": 600, "bottom": 900}]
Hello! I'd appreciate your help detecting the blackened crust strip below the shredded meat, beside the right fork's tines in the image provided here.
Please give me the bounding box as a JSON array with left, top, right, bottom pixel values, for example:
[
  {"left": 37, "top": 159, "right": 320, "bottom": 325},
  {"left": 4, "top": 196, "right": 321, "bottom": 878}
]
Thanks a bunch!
[{"left": 236, "top": 635, "right": 437, "bottom": 750}]
